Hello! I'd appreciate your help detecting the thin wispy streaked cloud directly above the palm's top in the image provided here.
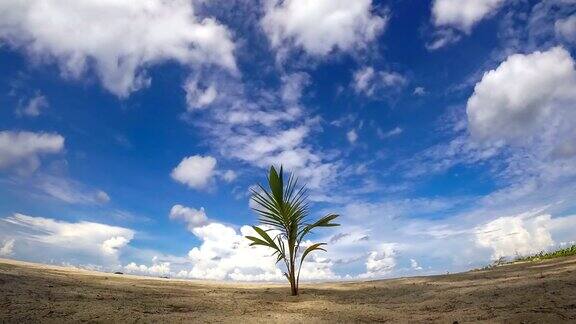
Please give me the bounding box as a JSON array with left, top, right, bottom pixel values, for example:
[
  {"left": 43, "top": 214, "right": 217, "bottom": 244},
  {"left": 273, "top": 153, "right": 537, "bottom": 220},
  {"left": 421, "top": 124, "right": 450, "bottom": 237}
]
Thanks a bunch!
[{"left": 187, "top": 72, "right": 336, "bottom": 194}]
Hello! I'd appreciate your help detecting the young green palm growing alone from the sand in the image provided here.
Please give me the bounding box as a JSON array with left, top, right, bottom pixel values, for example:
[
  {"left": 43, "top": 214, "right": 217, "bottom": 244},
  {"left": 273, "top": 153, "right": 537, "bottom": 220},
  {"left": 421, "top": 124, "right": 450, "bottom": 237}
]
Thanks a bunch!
[{"left": 246, "top": 167, "right": 340, "bottom": 296}]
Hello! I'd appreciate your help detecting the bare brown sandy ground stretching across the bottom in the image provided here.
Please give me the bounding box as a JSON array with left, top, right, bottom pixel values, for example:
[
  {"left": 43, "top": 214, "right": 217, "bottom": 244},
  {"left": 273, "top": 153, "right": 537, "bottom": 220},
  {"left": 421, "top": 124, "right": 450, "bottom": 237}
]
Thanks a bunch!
[{"left": 0, "top": 257, "right": 576, "bottom": 323}]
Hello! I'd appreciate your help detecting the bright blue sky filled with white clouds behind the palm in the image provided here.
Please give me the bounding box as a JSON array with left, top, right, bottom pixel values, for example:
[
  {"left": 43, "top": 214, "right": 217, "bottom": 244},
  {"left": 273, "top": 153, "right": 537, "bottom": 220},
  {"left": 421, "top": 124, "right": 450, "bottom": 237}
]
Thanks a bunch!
[{"left": 0, "top": 0, "right": 576, "bottom": 280}]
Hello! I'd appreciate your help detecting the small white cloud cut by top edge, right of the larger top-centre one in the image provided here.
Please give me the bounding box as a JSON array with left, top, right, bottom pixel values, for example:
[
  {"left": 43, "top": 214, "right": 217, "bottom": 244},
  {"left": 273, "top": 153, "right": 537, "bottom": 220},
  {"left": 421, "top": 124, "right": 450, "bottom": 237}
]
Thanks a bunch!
[{"left": 432, "top": 0, "right": 505, "bottom": 33}]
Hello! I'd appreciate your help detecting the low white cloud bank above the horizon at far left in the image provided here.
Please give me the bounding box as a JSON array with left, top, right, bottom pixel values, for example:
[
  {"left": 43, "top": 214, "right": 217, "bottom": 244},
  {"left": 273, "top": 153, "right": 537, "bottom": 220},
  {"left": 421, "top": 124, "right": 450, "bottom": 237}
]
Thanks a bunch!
[{"left": 0, "top": 213, "right": 134, "bottom": 266}]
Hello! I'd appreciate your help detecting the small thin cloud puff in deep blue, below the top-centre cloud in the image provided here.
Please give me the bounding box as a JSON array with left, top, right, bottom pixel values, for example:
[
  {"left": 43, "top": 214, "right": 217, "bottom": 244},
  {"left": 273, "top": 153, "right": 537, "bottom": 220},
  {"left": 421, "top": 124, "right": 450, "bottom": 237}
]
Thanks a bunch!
[{"left": 353, "top": 67, "right": 408, "bottom": 97}]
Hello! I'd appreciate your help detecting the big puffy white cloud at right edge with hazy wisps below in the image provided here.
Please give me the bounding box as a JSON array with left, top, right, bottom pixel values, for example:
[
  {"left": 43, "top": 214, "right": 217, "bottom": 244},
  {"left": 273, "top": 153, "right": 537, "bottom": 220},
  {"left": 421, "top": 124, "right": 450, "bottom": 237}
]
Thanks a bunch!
[{"left": 406, "top": 47, "right": 576, "bottom": 191}]
